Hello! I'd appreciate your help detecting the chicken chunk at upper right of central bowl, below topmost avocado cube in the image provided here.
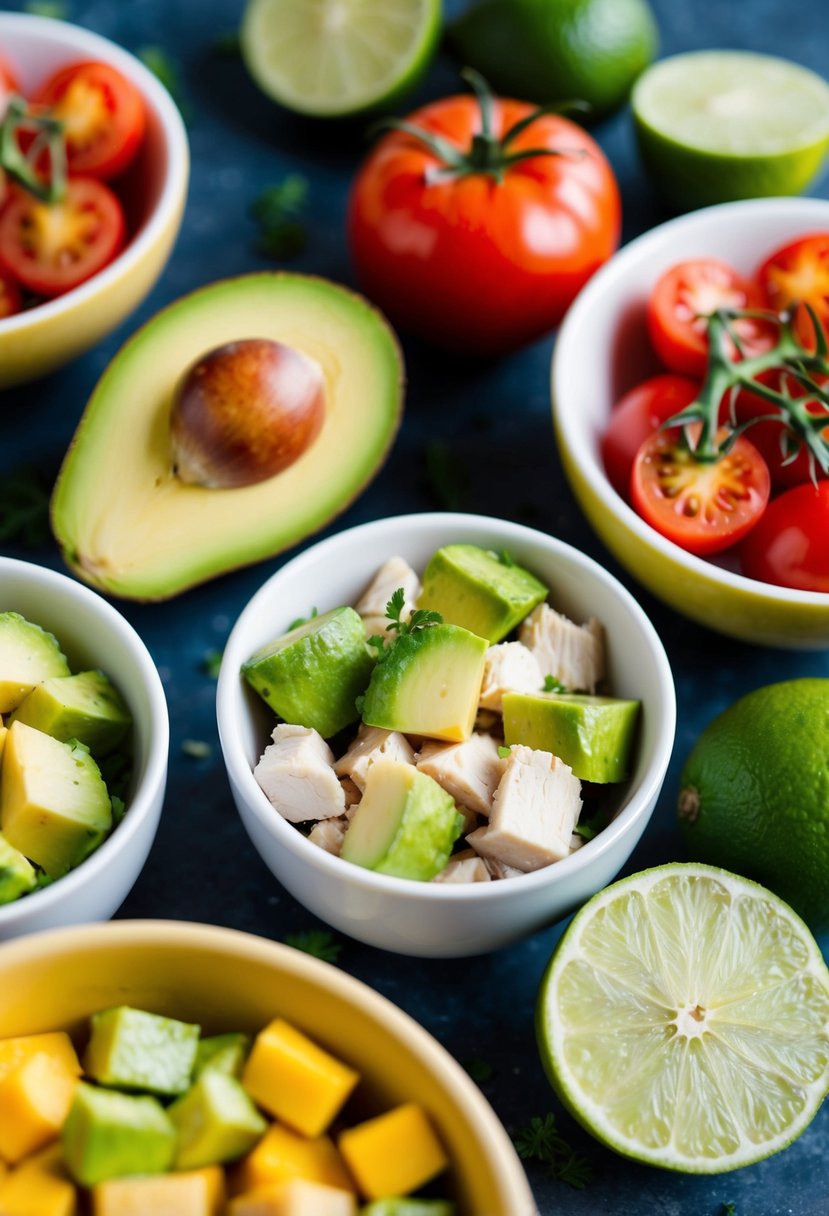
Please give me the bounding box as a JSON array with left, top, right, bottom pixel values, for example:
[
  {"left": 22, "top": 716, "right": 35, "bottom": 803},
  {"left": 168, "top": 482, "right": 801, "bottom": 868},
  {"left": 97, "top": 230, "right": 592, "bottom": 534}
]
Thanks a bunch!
[{"left": 518, "top": 604, "right": 604, "bottom": 692}]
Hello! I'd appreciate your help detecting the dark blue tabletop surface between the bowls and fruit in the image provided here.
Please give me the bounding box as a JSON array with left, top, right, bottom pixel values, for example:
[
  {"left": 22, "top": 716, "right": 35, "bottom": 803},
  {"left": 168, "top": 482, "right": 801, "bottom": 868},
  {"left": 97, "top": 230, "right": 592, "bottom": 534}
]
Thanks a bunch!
[{"left": 0, "top": 0, "right": 829, "bottom": 1216}]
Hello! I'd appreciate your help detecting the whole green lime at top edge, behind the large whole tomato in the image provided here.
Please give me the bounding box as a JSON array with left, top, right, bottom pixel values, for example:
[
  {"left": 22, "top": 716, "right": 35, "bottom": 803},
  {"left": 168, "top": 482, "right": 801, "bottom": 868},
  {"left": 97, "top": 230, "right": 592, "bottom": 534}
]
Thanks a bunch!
[{"left": 449, "top": 0, "right": 658, "bottom": 114}]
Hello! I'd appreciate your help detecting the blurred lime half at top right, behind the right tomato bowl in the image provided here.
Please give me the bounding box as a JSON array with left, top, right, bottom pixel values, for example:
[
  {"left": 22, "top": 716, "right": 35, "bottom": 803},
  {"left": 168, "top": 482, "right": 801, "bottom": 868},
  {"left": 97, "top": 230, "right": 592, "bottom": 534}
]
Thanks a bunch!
[{"left": 631, "top": 51, "right": 829, "bottom": 209}]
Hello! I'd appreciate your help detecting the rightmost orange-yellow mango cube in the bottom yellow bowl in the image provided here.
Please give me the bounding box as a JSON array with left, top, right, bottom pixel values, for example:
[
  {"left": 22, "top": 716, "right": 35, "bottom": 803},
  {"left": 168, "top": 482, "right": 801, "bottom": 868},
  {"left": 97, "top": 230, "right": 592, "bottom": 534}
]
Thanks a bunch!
[{"left": 337, "top": 1102, "right": 449, "bottom": 1199}]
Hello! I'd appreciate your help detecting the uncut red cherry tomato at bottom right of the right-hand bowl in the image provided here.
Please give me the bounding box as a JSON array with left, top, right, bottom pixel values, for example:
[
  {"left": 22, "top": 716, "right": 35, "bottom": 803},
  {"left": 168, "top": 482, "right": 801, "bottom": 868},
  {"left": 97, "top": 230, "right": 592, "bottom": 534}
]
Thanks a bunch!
[{"left": 740, "top": 482, "right": 829, "bottom": 593}]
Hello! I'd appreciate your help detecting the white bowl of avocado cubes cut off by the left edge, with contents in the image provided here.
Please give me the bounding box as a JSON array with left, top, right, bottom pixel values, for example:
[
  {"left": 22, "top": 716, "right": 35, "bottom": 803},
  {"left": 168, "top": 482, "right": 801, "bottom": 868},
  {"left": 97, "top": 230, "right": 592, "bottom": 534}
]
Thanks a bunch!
[{"left": 0, "top": 557, "right": 169, "bottom": 940}]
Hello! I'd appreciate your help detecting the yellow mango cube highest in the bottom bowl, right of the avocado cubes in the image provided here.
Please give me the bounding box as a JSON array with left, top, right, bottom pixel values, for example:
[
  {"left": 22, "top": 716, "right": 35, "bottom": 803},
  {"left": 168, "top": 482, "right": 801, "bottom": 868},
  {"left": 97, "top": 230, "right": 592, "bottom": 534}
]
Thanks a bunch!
[{"left": 242, "top": 1018, "right": 360, "bottom": 1136}]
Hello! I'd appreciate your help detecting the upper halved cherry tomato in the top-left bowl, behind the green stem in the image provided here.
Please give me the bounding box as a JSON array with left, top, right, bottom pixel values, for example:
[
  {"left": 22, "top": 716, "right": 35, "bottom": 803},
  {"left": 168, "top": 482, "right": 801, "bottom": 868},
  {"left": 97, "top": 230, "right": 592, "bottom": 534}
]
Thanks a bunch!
[{"left": 34, "top": 63, "right": 146, "bottom": 179}]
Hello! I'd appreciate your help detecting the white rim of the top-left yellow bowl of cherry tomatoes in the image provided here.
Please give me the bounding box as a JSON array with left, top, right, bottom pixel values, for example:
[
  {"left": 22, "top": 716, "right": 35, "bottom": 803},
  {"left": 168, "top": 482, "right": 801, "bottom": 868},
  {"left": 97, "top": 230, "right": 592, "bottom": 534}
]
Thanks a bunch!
[{"left": 0, "top": 12, "right": 190, "bottom": 333}]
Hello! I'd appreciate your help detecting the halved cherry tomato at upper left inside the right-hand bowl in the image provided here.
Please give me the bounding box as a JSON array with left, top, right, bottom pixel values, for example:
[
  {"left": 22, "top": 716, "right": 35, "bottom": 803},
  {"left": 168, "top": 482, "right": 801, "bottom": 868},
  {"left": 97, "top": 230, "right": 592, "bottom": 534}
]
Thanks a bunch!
[{"left": 647, "top": 258, "right": 774, "bottom": 377}]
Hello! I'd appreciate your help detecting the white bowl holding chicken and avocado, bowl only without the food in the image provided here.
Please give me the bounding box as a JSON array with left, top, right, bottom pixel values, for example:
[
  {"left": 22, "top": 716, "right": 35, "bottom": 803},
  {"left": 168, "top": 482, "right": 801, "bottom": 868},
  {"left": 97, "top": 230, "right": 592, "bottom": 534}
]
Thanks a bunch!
[{"left": 218, "top": 513, "right": 676, "bottom": 957}]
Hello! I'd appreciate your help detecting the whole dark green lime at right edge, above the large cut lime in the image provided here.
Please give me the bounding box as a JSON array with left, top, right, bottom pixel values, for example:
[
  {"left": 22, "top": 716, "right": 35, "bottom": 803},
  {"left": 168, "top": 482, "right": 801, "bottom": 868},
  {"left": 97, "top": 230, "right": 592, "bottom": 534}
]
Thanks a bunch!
[{"left": 678, "top": 679, "right": 829, "bottom": 929}]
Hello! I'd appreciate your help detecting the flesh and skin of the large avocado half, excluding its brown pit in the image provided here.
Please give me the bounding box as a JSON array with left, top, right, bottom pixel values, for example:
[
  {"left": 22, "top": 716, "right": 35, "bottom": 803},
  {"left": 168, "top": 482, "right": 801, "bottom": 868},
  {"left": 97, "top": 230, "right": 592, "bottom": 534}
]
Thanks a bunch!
[{"left": 51, "top": 272, "right": 404, "bottom": 599}]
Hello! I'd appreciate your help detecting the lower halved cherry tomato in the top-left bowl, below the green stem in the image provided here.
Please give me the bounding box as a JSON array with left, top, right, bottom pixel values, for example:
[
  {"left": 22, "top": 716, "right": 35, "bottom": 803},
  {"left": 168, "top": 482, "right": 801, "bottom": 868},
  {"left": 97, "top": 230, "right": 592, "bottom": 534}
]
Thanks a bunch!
[{"left": 0, "top": 178, "right": 126, "bottom": 297}]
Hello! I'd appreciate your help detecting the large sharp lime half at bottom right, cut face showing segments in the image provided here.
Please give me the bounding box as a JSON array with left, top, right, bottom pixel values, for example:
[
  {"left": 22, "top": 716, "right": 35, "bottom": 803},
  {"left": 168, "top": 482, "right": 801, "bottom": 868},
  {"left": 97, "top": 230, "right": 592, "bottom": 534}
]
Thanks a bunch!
[{"left": 536, "top": 863, "right": 829, "bottom": 1173}]
